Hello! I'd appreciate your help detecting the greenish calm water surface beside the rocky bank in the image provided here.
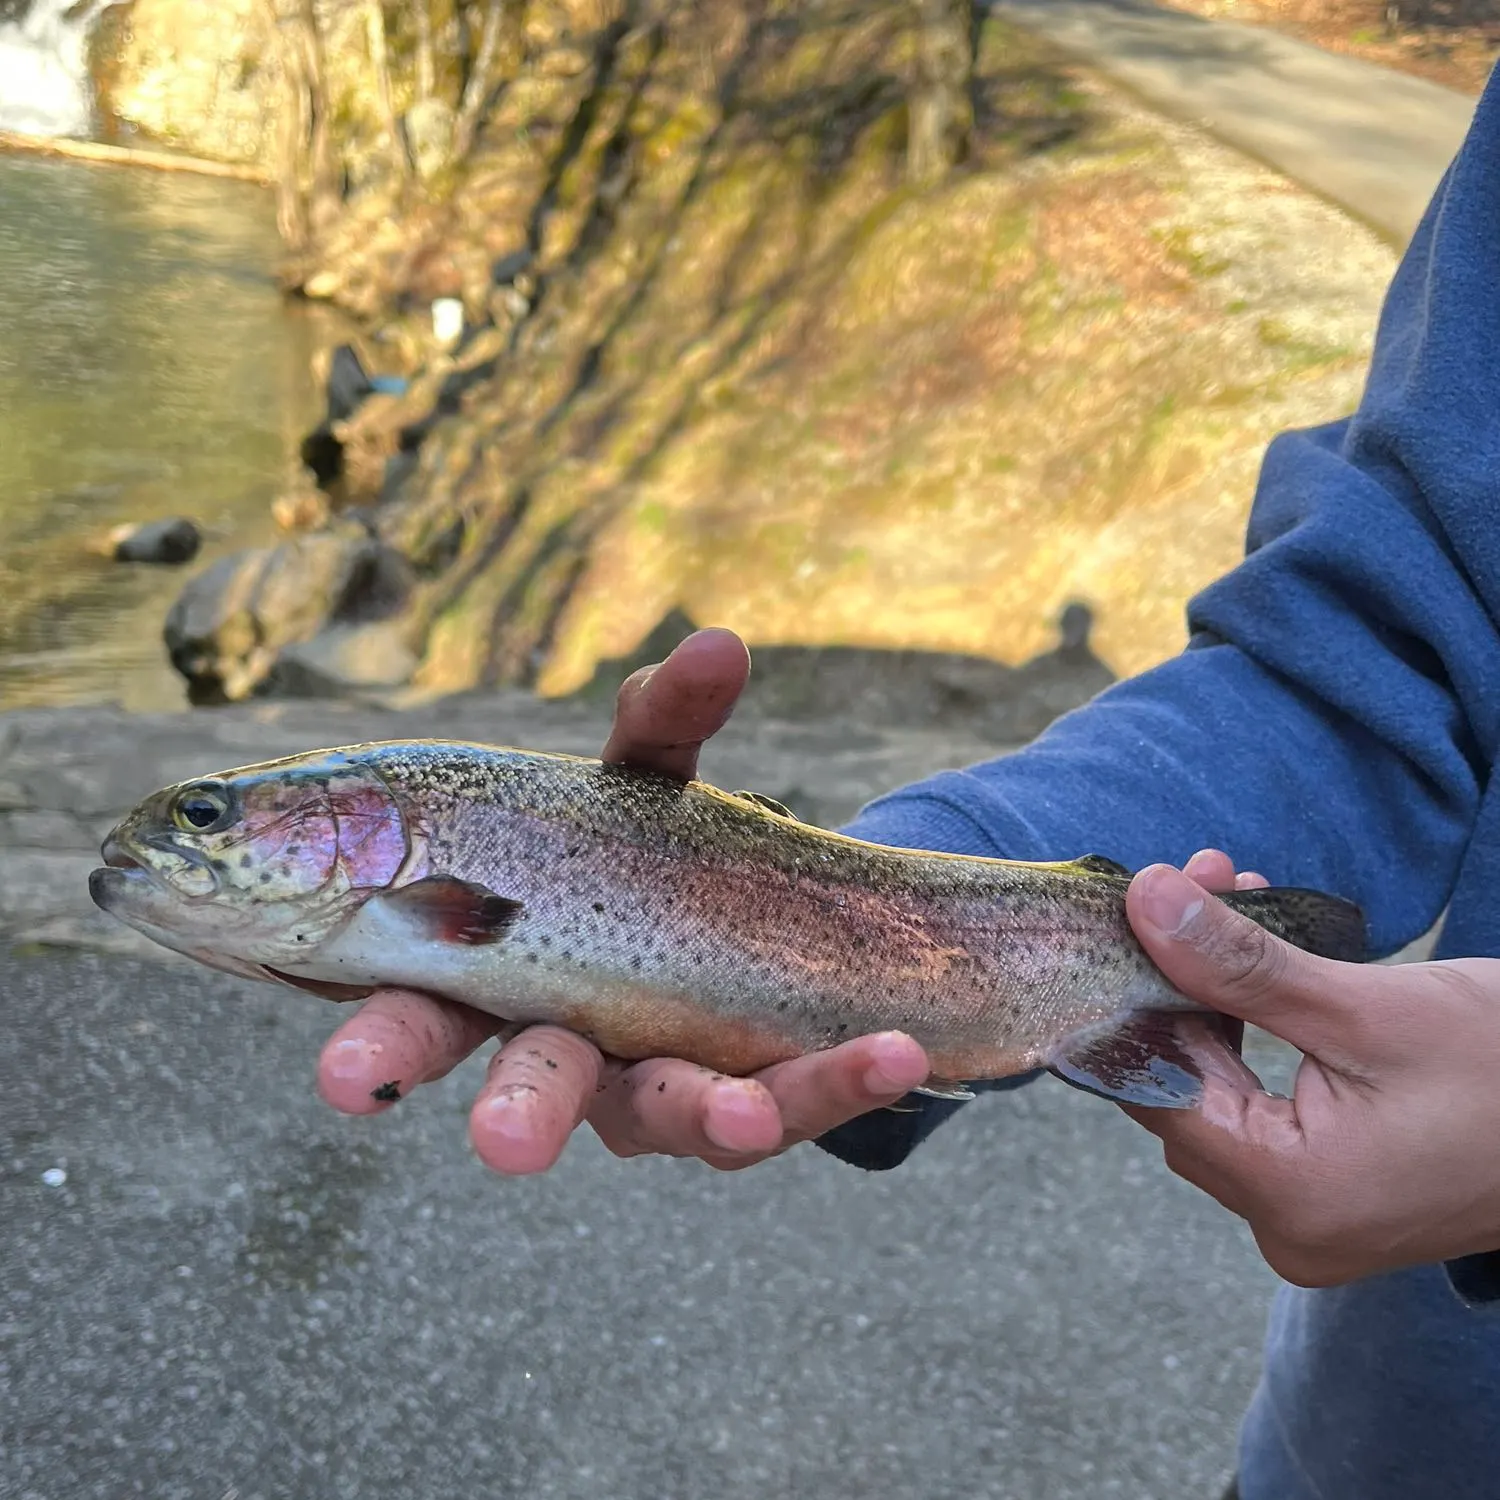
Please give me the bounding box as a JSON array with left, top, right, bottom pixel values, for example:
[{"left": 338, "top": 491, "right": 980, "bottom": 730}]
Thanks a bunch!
[{"left": 0, "top": 155, "right": 324, "bottom": 710}]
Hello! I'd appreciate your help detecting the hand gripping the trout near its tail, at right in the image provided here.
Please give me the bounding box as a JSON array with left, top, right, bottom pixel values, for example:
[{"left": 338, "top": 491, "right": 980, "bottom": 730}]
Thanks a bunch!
[{"left": 1125, "top": 855, "right": 1500, "bottom": 1287}]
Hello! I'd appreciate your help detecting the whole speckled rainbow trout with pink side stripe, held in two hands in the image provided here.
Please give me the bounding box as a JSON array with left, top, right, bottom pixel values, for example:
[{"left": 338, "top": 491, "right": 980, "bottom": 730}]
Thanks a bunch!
[{"left": 89, "top": 741, "right": 1364, "bottom": 1107}]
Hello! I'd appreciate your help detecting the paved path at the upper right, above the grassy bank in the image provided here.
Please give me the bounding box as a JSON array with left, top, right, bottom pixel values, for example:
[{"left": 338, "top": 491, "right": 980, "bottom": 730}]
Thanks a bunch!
[{"left": 990, "top": 0, "right": 1475, "bottom": 245}]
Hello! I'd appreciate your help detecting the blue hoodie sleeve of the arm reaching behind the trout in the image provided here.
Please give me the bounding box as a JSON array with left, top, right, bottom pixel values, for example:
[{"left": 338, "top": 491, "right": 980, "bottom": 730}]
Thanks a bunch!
[{"left": 821, "top": 64, "right": 1500, "bottom": 1296}]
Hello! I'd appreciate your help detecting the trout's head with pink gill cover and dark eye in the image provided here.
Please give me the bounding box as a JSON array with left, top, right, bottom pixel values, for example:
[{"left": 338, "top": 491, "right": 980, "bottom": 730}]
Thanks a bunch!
[{"left": 89, "top": 752, "right": 423, "bottom": 978}]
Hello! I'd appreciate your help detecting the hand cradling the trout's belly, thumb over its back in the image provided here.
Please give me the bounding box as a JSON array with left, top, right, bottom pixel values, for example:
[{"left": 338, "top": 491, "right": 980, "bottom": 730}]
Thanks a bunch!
[{"left": 318, "top": 630, "right": 930, "bottom": 1173}]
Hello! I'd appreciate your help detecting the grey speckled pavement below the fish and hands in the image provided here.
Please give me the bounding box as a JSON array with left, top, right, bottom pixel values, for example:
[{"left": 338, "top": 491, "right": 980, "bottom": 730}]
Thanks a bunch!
[{"left": 0, "top": 951, "right": 1271, "bottom": 1500}]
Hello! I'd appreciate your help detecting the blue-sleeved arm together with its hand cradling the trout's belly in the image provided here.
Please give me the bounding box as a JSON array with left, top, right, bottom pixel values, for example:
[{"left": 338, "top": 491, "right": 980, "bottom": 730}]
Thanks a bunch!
[{"left": 310, "top": 61, "right": 1500, "bottom": 1230}]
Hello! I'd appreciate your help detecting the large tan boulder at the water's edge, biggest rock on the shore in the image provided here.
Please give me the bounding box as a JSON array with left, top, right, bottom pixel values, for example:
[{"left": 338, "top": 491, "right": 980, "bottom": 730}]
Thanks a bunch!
[{"left": 162, "top": 525, "right": 413, "bottom": 704}]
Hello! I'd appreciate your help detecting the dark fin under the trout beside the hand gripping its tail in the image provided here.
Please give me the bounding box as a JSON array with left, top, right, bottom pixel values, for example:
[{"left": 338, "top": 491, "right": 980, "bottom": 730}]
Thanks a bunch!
[{"left": 1049, "top": 1011, "right": 1260, "bottom": 1110}]
